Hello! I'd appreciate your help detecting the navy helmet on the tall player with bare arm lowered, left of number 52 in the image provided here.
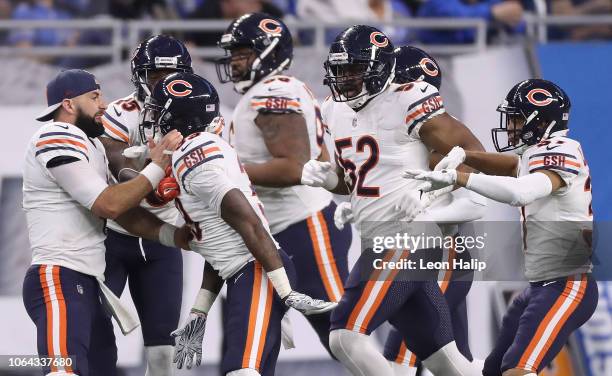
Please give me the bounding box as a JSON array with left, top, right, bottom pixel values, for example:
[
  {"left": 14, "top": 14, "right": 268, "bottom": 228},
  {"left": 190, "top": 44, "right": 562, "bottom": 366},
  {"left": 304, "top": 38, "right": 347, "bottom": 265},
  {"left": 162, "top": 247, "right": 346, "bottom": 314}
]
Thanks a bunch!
[{"left": 216, "top": 13, "right": 293, "bottom": 93}]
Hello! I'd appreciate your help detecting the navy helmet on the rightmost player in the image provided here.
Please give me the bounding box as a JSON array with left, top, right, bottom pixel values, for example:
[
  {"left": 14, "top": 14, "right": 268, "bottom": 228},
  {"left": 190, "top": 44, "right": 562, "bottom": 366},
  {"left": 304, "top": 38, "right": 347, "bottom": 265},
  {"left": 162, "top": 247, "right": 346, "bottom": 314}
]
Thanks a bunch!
[{"left": 491, "top": 78, "right": 571, "bottom": 152}]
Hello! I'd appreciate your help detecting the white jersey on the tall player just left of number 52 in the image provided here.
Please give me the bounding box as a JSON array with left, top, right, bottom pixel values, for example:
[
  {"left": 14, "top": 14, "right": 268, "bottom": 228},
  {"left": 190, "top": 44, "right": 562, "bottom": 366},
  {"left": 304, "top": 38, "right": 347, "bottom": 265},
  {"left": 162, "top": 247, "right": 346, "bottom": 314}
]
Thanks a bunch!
[{"left": 228, "top": 75, "right": 332, "bottom": 234}]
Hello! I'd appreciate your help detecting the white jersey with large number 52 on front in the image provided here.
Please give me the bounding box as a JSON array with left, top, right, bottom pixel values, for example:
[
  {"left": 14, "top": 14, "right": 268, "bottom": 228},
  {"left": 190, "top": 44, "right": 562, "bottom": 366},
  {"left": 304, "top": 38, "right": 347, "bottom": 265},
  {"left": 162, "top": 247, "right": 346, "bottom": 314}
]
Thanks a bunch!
[{"left": 323, "top": 81, "right": 445, "bottom": 228}]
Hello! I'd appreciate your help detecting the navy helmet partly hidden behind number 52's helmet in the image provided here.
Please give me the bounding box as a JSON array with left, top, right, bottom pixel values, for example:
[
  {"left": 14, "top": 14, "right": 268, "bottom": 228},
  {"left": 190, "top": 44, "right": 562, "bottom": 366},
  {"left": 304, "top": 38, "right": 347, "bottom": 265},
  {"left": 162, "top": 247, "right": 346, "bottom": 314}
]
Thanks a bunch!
[{"left": 393, "top": 46, "right": 442, "bottom": 90}]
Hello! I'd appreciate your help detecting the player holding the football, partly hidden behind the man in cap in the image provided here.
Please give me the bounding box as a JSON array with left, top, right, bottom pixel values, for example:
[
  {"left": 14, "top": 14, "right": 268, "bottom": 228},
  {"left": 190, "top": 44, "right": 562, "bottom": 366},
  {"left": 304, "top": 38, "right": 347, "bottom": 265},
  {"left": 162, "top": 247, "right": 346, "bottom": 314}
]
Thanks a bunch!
[{"left": 100, "top": 35, "right": 192, "bottom": 376}]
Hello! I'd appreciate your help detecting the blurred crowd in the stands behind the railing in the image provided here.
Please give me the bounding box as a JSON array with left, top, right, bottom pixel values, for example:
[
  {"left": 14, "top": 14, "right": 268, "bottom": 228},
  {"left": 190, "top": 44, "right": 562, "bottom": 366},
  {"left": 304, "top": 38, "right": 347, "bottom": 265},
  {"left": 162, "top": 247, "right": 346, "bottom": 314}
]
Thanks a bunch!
[{"left": 0, "top": 0, "right": 612, "bottom": 66}]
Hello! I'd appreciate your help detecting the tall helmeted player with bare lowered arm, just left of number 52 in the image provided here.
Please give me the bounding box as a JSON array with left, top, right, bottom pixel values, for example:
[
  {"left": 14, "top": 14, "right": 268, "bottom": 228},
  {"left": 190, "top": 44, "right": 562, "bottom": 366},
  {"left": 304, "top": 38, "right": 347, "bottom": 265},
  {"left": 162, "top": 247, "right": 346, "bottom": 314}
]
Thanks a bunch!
[{"left": 217, "top": 13, "right": 352, "bottom": 351}]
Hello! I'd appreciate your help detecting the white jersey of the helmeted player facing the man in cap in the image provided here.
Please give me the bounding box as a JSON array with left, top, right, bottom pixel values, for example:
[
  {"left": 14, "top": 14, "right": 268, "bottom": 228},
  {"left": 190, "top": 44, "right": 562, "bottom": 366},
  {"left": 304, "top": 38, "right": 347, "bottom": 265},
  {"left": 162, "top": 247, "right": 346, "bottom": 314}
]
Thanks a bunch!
[{"left": 172, "top": 132, "right": 278, "bottom": 279}]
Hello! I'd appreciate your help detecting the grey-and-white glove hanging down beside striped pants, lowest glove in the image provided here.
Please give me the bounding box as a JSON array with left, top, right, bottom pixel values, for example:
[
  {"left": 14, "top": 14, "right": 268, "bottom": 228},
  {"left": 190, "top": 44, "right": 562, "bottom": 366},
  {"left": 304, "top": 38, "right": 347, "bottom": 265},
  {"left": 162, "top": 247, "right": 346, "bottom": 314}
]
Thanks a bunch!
[{"left": 170, "top": 310, "right": 206, "bottom": 369}]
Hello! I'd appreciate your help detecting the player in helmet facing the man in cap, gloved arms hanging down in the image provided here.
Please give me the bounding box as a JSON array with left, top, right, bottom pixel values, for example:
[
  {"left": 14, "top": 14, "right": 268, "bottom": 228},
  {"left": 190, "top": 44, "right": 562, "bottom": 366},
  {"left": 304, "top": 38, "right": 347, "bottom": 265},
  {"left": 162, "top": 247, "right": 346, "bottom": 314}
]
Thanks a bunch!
[{"left": 143, "top": 73, "right": 336, "bottom": 376}]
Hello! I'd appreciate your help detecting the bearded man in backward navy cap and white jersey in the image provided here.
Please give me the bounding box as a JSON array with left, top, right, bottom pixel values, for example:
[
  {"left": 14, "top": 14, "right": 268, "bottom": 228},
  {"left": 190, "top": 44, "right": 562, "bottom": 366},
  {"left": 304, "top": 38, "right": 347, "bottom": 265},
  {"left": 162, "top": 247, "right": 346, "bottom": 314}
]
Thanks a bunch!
[{"left": 23, "top": 69, "right": 189, "bottom": 376}]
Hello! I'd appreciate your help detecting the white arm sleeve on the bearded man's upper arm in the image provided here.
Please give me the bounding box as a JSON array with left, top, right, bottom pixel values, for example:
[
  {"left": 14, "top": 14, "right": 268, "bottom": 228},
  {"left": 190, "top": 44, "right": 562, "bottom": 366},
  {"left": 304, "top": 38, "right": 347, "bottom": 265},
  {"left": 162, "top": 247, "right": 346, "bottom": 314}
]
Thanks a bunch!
[{"left": 49, "top": 161, "right": 108, "bottom": 209}]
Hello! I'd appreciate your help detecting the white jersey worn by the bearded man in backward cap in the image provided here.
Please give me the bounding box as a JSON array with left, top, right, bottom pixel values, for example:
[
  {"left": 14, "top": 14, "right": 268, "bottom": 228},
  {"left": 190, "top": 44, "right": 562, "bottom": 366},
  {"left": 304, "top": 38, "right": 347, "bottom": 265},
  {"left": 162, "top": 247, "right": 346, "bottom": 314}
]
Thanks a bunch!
[{"left": 23, "top": 122, "right": 108, "bottom": 277}]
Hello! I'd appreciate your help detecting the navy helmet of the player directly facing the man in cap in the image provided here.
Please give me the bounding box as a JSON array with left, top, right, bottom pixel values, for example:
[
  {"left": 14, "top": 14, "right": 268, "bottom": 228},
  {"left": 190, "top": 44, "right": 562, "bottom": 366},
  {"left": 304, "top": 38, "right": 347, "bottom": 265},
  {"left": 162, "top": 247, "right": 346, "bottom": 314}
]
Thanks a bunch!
[{"left": 140, "top": 72, "right": 222, "bottom": 137}]
